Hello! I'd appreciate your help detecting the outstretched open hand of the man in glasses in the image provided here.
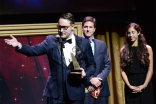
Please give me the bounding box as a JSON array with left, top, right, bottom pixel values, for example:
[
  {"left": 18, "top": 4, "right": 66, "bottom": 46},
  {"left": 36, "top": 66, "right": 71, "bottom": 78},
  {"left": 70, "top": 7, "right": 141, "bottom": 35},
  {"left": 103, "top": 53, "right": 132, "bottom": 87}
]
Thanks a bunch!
[{"left": 4, "top": 35, "right": 22, "bottom": 49}]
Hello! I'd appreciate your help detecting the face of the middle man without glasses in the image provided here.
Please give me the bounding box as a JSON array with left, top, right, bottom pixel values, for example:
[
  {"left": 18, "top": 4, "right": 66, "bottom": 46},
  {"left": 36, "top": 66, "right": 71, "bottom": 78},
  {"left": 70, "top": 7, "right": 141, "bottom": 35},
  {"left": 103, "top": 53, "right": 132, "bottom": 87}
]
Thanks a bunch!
[{"left": 82, "top": 21, "right": 96, "bottom": 38}]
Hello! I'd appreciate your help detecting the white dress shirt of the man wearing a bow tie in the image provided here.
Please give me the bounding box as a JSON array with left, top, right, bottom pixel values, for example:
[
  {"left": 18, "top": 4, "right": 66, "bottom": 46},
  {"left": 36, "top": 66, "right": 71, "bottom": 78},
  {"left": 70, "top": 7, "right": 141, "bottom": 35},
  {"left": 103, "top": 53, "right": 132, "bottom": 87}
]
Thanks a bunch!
[{"left": 63, "top": 34, "right": 76, "bottom": 66}]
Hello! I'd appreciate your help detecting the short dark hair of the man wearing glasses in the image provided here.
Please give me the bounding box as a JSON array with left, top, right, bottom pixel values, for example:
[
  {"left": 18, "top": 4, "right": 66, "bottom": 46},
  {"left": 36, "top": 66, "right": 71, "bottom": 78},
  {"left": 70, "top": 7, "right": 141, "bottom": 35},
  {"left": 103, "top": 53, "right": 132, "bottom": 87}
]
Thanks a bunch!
[{"left": 59, "top": 13, "right": 75, "bottom": 24}]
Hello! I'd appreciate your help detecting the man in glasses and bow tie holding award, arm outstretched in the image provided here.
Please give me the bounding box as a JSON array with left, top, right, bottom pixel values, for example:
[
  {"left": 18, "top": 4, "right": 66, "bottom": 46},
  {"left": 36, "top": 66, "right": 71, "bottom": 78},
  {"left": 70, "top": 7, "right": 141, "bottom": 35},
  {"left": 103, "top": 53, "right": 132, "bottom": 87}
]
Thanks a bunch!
[{"left": 5, "top": 13, "right": 95, "bottom": 104}]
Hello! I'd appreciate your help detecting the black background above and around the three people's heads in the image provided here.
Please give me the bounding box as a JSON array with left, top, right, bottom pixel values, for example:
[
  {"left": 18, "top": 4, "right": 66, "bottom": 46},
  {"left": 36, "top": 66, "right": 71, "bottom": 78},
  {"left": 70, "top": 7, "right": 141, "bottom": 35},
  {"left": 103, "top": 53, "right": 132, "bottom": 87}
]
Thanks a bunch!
[{"left": 0, "top": 0, "right": 156, "bottom": 103}]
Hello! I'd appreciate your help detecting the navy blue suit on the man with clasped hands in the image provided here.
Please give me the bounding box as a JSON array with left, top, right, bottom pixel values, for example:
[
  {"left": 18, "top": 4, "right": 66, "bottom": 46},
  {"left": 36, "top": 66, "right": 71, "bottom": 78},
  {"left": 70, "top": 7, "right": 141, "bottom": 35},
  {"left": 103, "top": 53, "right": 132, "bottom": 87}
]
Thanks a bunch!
[{"left": 85, "top": 39, "right": 111, "bottom": 104}]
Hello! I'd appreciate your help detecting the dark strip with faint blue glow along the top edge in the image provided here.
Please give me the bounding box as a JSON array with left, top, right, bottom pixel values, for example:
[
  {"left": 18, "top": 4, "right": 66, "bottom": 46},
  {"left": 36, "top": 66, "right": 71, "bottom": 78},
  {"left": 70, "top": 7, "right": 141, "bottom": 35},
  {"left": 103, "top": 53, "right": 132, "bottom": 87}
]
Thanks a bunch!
[{"left": 0, "top": 0, "right": 135, "bottom": 14}]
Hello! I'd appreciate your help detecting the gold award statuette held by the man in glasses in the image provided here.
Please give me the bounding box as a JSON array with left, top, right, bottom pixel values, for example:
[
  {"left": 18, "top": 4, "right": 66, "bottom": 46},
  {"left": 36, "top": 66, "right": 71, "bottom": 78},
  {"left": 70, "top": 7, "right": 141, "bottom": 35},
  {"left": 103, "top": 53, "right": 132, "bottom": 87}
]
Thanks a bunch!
[{"left": 70, "top": 53, "right": 82, "bottom": 75}]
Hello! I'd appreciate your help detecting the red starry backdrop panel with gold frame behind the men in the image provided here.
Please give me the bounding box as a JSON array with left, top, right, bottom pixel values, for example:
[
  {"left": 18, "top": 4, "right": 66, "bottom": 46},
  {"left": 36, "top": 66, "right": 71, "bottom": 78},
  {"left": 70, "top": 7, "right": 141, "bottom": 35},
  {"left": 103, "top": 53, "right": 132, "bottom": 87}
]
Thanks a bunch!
[{"left": 0, "top": 22, "right": 82, "bottom": 104}]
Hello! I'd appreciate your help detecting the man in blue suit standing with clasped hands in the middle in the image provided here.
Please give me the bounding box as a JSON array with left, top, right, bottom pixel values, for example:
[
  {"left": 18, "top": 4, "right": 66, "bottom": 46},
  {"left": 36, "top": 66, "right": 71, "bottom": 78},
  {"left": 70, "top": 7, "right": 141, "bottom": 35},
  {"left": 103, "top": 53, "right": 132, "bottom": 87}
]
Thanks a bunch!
[{"left": 82, "top": 16, "right": 111, "bottom": 104}]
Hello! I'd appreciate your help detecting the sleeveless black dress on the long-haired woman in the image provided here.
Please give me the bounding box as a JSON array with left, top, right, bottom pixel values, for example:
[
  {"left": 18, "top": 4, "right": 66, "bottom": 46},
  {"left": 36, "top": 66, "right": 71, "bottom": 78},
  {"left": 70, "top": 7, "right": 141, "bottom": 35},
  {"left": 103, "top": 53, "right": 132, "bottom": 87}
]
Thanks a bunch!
[{"left": 125, "top": 47, "right": 154, "bottom": 104}]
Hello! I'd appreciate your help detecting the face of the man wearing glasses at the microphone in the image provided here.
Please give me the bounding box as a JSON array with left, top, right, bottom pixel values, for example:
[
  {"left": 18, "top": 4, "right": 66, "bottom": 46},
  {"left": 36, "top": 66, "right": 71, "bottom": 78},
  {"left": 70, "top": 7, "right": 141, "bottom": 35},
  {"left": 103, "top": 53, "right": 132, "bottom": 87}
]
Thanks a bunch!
[{"left": 58, "top": 18, "right": 74, "bottom": 39}]
